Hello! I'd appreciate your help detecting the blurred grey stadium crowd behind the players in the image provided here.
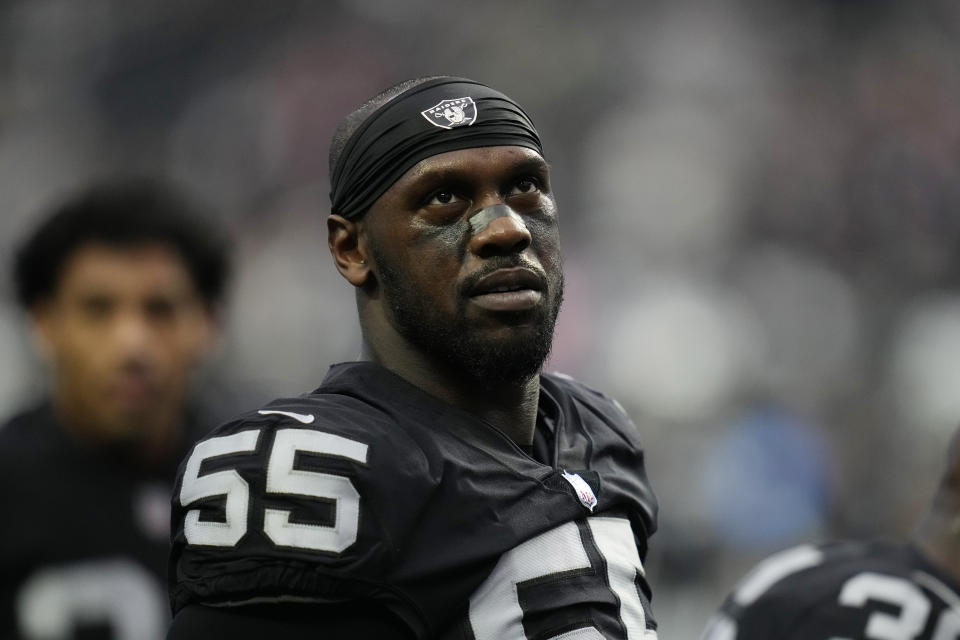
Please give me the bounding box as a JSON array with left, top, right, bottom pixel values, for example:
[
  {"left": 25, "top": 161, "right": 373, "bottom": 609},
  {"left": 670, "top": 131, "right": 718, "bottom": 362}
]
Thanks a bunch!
[{"left": 0, "top": 0, "right": 960, "bottom": 638}]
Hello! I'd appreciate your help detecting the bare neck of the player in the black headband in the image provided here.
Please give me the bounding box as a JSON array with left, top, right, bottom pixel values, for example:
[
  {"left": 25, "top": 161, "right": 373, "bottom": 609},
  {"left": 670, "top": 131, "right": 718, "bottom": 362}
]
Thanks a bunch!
[{"left": 363, "top": 342, "right": 540, "bottom": 445}]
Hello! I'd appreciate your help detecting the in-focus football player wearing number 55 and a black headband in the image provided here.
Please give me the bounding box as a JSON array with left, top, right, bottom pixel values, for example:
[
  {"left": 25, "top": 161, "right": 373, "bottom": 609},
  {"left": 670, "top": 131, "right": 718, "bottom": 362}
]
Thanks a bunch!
[{"left": 169, "top": 76, "right": 657, "bottom": 640}]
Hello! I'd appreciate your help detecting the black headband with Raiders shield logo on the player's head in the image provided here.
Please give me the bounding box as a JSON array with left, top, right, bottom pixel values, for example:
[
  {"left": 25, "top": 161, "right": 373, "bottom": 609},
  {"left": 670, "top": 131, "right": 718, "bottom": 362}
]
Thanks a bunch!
[{"left": 330, "top": 77, "right": 543, "bottom": 219}]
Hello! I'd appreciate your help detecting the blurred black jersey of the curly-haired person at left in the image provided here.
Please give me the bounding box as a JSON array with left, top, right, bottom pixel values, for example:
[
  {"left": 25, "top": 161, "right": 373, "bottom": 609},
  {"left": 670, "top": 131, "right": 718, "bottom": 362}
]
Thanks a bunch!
[{"left": 0, "top": 404, "right": 200, "bottom": 640}]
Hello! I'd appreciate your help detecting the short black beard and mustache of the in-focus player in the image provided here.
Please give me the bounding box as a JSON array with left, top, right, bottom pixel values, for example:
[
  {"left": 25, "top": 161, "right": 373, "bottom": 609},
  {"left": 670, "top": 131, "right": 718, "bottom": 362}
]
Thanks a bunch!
[{"left": 377, "top": 258, "right": 563, "bottom": 388}]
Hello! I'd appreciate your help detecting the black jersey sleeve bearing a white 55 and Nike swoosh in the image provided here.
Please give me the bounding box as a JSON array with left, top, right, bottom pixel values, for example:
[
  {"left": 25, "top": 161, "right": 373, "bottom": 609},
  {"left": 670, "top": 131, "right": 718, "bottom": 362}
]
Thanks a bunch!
[{"left": 169, "top": 400, "right": 432, "bottom": 632}]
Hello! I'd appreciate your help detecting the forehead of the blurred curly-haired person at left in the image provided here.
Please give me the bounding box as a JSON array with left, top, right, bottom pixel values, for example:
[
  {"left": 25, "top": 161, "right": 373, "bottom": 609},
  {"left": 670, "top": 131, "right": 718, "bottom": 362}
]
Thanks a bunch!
[{"left": 54, "top": 243, "right": 193, "bottom": 295}]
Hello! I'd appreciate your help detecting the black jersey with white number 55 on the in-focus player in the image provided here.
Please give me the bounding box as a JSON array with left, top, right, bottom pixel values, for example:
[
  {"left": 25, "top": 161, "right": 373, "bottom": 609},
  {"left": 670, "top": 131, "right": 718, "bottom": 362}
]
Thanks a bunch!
[{"left": 170, "top": 363, "right": 657, "bottom": 640}]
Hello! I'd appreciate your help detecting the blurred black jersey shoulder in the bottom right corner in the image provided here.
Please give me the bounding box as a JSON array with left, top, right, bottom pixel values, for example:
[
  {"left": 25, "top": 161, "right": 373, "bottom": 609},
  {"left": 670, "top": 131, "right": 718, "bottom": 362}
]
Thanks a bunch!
[{"left": 702, "top": 542, "right": 960, "bottom": 640}]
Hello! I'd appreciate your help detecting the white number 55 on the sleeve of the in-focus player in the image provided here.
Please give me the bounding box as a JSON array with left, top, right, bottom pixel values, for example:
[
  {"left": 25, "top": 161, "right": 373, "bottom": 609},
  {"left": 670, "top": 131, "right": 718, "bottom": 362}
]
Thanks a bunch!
[{"left": 174, "top": 429, "right": 367, "bottom": 553}]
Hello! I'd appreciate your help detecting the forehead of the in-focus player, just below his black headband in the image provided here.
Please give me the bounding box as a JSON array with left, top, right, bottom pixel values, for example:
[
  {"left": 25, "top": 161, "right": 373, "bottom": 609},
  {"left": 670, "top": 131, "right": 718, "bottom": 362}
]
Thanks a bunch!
[{"left": 384, "top": 146, "right": 549, "bottom": 195}]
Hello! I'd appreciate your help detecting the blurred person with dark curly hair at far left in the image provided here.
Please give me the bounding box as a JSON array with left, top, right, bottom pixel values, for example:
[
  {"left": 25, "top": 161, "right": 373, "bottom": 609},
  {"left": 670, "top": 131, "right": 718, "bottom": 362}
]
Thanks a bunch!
[{"left": 0, "top": 178, "right": 229, "bottom": 640}]
